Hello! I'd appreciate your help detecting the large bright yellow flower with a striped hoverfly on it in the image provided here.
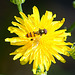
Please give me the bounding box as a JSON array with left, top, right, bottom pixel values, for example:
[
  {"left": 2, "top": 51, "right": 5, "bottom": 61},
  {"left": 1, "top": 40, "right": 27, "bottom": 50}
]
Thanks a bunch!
[{"left": 5, "top": 6, "right": 72, "bottom": 74}]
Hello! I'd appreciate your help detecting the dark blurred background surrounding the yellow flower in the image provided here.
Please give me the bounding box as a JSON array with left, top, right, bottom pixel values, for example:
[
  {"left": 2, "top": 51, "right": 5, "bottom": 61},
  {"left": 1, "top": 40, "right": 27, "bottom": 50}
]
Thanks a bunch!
[{"left": 0, "top": 0, "right": 75, "bottom": 75}]
